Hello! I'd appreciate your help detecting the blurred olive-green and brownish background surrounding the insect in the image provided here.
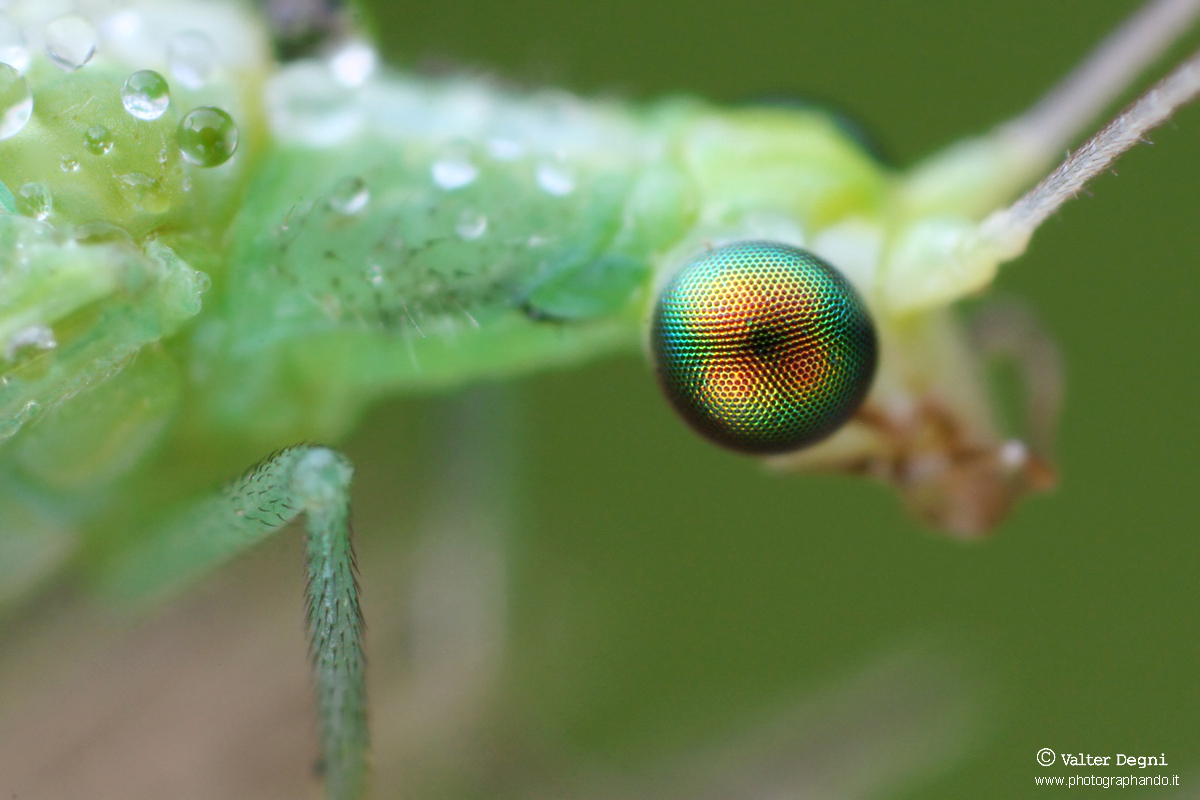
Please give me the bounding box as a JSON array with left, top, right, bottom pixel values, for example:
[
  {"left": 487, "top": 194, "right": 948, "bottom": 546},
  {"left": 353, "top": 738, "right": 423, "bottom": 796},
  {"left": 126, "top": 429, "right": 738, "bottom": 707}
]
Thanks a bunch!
[{"left": 0, "top": 0, "right": 1200, "bottom": 800}]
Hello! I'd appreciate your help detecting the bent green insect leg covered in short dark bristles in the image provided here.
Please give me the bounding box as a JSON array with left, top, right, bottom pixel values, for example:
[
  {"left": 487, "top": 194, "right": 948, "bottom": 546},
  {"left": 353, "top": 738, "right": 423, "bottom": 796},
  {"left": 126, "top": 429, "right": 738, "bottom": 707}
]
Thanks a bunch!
[{"left": 100, "top": 446, "right": 367, "bottom": 800}]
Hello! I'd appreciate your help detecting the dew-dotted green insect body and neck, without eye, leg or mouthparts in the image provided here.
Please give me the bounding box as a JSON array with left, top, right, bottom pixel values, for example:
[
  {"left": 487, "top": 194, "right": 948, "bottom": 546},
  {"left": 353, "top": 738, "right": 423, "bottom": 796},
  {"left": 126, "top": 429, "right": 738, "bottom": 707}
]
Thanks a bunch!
[{"left": 0, "top": 0, "right": 889, "bottom": 594}]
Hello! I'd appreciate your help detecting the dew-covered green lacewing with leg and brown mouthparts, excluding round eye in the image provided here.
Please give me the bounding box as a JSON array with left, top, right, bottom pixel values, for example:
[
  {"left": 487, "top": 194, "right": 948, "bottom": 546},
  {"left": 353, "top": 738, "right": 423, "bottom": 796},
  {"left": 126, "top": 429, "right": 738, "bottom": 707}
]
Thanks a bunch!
[{"left": 0, "top": 4, "right": 1187, "bottom": 796}]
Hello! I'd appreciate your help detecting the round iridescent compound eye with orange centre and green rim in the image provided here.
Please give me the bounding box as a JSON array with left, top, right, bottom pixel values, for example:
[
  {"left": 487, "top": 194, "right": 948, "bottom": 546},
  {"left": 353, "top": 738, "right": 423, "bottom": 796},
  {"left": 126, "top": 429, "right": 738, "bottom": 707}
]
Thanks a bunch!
[{"left": 650, "top": 241, "right": 877, "bottom": 453}]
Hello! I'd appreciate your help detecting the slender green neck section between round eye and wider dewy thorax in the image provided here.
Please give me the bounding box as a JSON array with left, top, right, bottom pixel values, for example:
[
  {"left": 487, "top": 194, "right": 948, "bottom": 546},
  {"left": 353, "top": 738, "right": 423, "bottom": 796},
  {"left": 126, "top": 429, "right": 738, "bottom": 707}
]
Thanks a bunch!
[{"left": 201, "top": 98, "right": 878, "bottom": 450}]
